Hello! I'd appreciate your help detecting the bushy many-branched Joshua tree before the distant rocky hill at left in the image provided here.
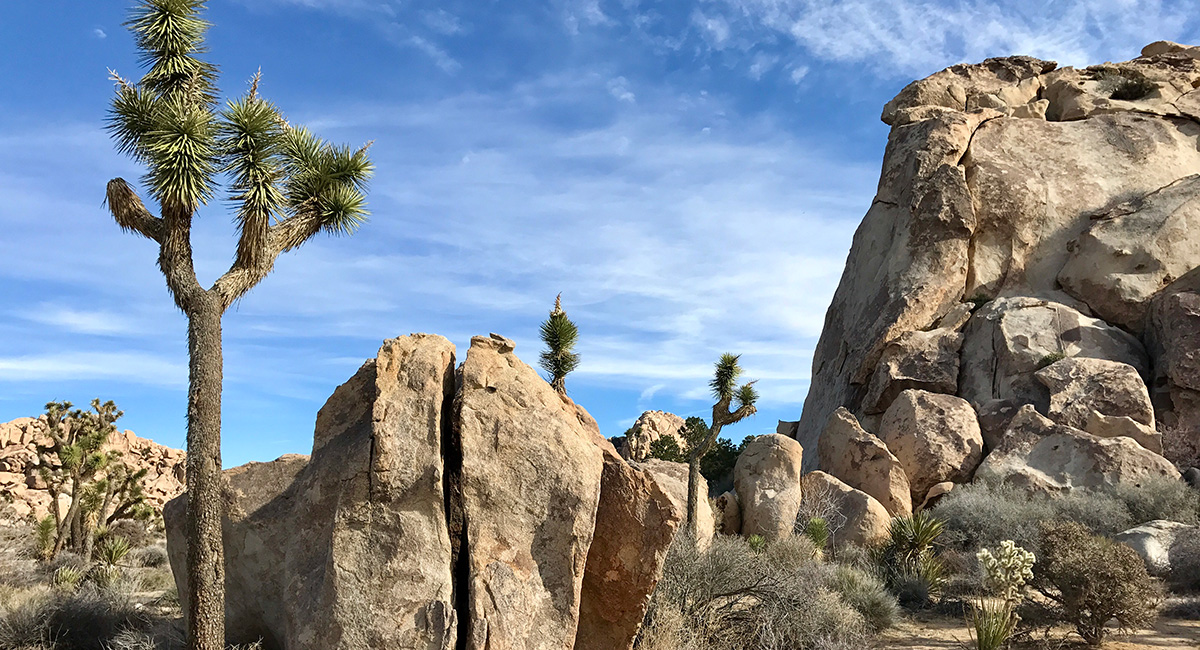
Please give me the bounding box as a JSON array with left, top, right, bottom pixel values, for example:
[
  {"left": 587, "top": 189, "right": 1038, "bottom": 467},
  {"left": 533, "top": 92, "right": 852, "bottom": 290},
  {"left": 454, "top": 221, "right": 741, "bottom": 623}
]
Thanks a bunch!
[{"left": 37, "top": 399, "right": 149, "bottom": 559}]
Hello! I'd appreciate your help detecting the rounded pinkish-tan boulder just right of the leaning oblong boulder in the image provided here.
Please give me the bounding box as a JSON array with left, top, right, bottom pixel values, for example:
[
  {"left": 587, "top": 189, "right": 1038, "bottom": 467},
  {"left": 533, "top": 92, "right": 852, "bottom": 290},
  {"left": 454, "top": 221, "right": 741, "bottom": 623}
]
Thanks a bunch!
[{"left": 880, "top": 390, "right": 983, "bottom": 504}]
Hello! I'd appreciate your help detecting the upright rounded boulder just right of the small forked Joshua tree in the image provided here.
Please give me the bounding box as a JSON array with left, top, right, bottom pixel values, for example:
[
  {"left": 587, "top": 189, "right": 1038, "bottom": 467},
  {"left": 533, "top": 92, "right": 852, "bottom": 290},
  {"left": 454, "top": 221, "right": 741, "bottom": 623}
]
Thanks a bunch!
[{"left": 733, "top": 433, "right": 804, "bottom": 540}]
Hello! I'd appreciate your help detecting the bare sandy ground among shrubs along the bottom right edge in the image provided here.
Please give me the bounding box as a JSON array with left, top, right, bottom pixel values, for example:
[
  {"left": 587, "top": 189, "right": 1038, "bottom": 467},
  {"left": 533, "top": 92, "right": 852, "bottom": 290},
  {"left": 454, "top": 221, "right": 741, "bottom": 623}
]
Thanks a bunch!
[{"left": 880, "top": 614, "right": 1200, "bottom": 650}]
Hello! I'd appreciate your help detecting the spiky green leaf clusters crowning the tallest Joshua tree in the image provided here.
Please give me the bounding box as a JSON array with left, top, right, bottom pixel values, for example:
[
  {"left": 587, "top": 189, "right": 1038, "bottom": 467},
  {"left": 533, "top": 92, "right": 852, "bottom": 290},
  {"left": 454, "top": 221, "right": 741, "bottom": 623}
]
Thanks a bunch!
[{"left": 108, "top": 0, "right": 372, "bottom": 231}]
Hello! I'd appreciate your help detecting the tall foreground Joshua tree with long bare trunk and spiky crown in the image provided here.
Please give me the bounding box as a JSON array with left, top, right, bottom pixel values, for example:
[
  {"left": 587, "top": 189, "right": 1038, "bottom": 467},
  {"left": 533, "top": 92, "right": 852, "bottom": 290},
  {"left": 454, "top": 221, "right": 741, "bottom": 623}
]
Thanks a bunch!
[{"left": 107, "top": 0, "right": 372, "bottom": 650}]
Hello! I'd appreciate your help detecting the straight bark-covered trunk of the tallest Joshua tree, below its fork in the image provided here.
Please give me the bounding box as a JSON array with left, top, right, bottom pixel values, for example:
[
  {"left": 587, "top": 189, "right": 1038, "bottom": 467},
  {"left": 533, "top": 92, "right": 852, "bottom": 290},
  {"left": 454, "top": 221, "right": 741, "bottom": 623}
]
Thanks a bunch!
[{"left": 187, "top": 298, "right": 224, "bottom": 650}]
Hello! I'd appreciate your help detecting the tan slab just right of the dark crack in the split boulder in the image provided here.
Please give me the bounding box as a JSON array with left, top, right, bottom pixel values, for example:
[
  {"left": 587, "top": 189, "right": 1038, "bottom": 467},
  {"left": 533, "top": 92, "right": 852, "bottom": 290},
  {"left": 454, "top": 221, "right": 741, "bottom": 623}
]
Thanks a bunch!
[{"left": 457, "top": 336, "right": 604, "bottom": 650}]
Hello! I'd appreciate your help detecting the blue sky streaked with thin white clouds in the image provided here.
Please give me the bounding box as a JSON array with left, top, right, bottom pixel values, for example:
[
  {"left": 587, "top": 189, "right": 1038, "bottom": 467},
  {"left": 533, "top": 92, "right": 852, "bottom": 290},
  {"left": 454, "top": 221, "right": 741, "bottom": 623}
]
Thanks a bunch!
[{"left": 0, "top": 0, "right": 1200, "bottom": 467}]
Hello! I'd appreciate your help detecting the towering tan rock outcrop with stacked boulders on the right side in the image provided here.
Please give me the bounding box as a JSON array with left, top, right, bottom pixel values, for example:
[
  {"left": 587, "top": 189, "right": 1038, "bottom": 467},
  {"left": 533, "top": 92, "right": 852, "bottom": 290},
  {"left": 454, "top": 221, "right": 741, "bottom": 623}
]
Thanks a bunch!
[{"left": 781, "top": 43, "right": 1200, "bottom": 505}]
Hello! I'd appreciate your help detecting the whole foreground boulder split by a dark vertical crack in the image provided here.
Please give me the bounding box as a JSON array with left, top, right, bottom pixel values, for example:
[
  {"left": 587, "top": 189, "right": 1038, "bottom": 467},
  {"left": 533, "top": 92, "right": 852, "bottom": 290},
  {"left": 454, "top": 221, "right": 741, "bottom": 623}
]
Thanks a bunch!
[{"left": 164, "top": 335, "right": 683, "bottom": 650}]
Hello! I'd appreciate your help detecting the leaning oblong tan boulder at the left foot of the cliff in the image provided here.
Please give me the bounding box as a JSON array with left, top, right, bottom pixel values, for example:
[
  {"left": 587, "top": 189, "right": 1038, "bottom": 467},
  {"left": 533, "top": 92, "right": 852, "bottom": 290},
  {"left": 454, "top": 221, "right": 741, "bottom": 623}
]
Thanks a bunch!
[{"left": 817, "top": 409, "right": 912, "bottom": 516}]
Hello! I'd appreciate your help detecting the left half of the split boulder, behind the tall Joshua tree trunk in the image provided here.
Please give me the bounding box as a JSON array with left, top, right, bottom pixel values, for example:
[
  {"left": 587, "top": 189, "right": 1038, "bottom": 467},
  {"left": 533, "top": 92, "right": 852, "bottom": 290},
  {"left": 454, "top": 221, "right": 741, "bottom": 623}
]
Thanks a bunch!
[{"left": 163, "top": 335, "right": 457, "bottom": 650}]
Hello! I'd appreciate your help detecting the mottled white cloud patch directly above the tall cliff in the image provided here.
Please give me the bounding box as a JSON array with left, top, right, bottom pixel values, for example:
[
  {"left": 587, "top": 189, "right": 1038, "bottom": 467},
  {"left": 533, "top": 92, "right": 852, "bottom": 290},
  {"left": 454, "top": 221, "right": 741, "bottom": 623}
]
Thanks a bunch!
[{"left": 707, "top": 0, "right": 1200, "bottom": 76}]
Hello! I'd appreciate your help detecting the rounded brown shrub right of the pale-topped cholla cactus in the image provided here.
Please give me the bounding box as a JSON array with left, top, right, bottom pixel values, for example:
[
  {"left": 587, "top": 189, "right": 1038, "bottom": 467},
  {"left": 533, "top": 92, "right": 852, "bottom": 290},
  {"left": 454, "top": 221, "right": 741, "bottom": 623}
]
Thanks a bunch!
[{"left": 1034, "top": 522, "right": 1160, "bottom": 645}]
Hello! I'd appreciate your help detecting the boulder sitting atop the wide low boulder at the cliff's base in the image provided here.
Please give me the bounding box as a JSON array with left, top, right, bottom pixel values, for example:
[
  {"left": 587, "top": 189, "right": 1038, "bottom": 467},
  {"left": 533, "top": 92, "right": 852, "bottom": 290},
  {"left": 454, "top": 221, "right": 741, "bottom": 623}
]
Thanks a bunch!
[{"left": 1034, "top": 357, "right": 1162, "bottom": 434}]
